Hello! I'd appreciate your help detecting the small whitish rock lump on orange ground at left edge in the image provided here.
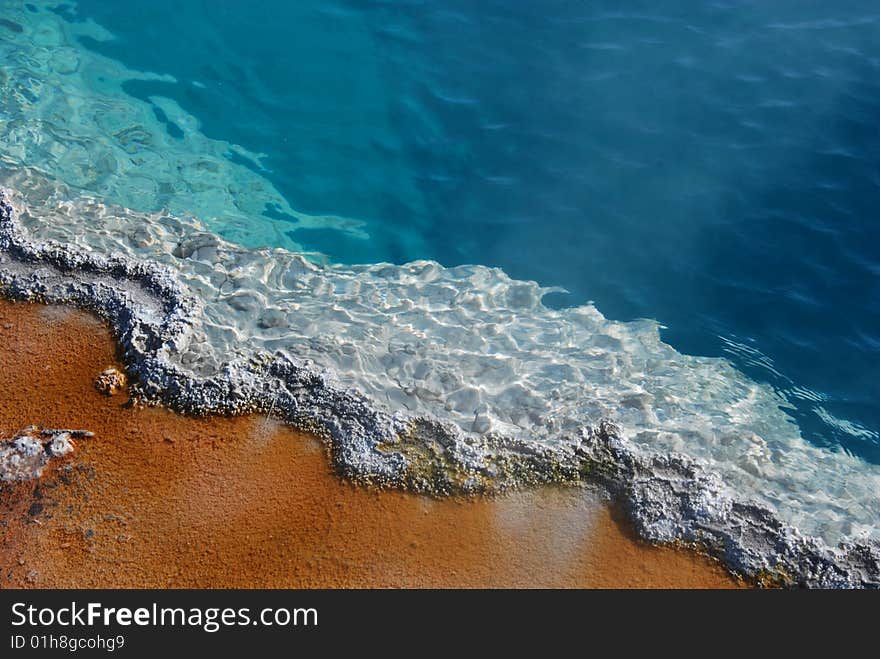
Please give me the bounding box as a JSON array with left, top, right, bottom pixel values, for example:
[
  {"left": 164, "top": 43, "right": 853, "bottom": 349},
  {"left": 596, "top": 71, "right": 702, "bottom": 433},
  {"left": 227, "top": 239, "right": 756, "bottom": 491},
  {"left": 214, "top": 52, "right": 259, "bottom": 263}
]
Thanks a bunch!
[{"left": 0, "top": 426, "right": 92, "bottom": 481}]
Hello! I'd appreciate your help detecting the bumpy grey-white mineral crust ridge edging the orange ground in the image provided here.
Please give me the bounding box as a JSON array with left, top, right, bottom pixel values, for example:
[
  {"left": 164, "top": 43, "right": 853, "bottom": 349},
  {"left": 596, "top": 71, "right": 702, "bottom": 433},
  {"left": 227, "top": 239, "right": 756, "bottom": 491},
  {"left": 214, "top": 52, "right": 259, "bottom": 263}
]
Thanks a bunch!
[{"left": 0, "top": 191, "right": 880, "bottom": 587}]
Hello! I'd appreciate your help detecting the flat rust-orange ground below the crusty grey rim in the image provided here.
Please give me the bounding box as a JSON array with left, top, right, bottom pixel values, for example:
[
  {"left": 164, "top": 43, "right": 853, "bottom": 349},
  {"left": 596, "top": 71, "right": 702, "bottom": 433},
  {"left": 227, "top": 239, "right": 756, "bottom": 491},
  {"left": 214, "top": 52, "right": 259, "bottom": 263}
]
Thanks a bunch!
[{"left": 0, "top": 301, "right": 739, "bottom": 588}]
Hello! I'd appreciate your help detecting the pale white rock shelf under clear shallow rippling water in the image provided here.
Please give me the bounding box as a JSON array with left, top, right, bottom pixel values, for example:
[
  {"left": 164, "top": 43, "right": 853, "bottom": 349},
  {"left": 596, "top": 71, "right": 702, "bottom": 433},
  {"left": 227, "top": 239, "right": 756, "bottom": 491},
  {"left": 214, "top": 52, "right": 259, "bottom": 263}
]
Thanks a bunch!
[{"left": 6, "top": 177, "right": 880, "bottom": 546}]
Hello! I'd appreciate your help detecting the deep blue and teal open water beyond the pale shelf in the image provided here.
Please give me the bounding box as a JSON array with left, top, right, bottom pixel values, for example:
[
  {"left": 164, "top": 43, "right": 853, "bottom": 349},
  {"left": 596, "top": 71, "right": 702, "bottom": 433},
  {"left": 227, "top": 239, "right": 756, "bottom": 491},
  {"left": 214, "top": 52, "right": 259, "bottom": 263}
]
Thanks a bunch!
[{"left": 13, "top": 0, "right": 880, "bottom": 463}]
